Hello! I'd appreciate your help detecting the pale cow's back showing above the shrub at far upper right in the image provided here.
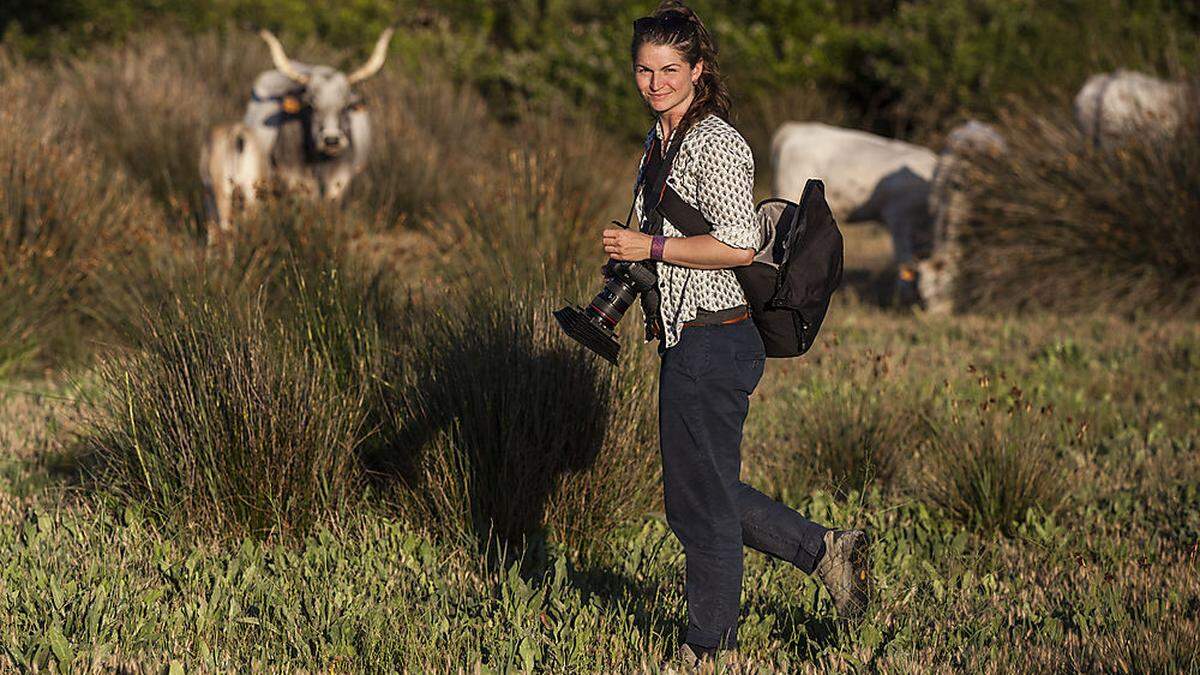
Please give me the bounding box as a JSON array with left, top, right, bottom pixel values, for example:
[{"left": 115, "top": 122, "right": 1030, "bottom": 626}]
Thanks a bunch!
[{"left": 1075, "top": 70, "right": 1188, "bottom": 145}]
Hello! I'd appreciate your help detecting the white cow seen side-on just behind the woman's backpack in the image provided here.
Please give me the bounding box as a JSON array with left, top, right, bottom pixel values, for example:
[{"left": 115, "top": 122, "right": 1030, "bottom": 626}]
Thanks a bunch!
[{"left": 772, "top": 123, "right": 937, "bottom": 301}]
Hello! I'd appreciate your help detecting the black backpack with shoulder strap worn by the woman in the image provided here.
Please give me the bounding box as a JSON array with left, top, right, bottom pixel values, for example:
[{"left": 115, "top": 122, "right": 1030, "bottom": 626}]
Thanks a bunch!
[{"left": 635, "top": 127, "right": 844, "bottom": 358}]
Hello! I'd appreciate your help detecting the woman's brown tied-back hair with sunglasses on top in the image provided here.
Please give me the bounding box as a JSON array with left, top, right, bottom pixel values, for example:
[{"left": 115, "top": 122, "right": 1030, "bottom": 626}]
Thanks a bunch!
[{"left": 630, "top": 0, "right": 730, "bottom": 137}]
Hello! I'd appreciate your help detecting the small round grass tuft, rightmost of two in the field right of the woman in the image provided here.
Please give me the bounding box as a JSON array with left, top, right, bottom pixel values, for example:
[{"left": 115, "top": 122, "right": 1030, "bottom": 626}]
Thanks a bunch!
[{"left": 913, "top": 375, "right": 1081, "bottom": 532}]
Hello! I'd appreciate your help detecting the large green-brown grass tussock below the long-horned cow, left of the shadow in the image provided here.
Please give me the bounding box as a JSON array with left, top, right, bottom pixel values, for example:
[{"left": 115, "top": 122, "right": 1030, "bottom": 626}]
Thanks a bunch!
[{"left": 83, "top": 263, "right": 374, "bottom": 536}]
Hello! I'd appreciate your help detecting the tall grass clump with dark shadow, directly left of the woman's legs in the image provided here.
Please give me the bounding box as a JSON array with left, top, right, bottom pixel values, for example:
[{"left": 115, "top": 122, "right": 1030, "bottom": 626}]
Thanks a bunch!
[{"left": 378, "top": 283, "right": 658, "bottom": 549}]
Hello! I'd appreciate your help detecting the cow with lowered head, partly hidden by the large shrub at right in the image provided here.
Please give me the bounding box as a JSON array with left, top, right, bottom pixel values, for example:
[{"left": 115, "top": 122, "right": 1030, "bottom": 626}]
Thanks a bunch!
[{"left": 917, "top": 120, "right": 1007, "bottom": 313}]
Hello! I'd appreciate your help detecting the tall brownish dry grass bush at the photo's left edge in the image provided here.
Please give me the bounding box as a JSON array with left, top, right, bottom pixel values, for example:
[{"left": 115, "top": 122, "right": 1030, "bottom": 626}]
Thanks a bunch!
[{"left": 0, "top": 64, "right": 158, "bottom": 372}]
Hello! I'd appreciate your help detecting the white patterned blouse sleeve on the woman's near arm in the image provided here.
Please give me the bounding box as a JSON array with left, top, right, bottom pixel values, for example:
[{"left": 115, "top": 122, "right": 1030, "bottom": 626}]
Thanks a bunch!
[{"left": 695, "top": 133, "right": 761, "bottom": 250}]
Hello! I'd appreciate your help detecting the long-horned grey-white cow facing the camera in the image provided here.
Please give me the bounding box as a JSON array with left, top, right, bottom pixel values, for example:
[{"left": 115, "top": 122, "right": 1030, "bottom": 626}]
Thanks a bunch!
[{"left": 200, "top": 28, "right": 394, "bottom": 244}]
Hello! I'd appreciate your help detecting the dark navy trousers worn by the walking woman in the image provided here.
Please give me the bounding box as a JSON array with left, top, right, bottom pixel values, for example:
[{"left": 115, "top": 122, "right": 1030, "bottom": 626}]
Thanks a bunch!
[{"left": 659, "top": 321, "right": 827, "bottom": 649}]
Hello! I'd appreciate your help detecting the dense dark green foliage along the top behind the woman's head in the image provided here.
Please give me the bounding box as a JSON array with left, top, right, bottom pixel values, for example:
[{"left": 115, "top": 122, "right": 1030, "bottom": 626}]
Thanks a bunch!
[{"left": 0, "top": 0, "right": 1200, "bottom": 136}]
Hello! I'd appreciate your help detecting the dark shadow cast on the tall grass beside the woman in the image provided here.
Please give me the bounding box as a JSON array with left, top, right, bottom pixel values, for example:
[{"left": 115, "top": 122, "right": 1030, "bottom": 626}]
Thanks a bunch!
[{"left": 364, "top": 294, "right": 612, "bottom": 567}]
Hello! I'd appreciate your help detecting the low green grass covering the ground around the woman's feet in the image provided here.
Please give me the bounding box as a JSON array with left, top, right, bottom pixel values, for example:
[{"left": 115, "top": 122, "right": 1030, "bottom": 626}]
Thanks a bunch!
[{"left": 0, "top": 303, "right": 1200, "bottom": 671}]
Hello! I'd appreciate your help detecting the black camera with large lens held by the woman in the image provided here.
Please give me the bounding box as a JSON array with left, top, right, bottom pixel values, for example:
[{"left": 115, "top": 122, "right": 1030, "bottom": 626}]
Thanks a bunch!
[{"left": 554, "top": 259, "right": 658, "bottom": 365}]
